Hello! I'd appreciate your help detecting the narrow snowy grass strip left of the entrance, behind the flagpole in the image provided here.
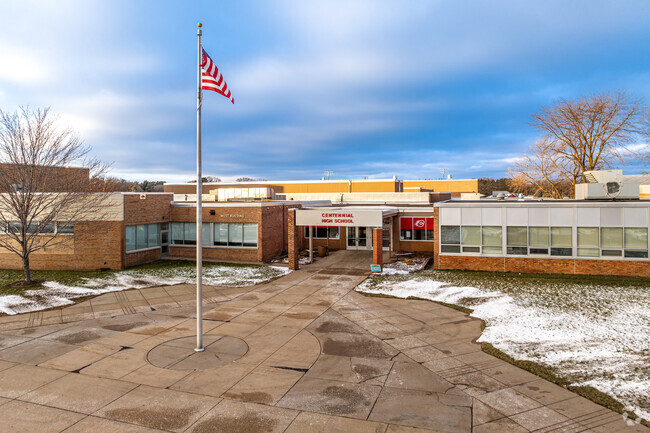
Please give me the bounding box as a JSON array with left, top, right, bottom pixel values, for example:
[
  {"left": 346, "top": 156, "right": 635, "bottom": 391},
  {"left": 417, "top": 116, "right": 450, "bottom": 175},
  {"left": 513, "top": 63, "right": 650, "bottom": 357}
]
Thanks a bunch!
[{"left": 0, "top": 264, "right": 291, "bottom": 314}]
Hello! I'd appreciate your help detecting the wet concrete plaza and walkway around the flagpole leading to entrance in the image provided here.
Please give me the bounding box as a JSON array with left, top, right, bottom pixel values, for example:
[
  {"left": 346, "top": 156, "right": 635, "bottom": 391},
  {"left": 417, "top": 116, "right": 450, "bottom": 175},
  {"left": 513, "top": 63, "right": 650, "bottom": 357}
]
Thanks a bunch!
[{"left": 0, "top": 251, "right": 649, "bottom": 433}]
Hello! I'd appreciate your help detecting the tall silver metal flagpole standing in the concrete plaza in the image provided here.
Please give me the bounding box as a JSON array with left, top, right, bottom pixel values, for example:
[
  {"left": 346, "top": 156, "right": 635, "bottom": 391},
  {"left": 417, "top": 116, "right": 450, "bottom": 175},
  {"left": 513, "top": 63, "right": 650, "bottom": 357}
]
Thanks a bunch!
[{"left": 194, "top": 23, "right": 205, "bottom": 352}]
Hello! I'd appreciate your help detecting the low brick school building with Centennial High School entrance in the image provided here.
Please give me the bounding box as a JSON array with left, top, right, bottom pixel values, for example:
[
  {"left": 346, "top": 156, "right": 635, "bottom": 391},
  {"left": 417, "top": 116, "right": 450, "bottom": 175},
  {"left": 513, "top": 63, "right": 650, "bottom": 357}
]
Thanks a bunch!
[{"left": 0, "top": 173, "right": 650, "bottom": 277}]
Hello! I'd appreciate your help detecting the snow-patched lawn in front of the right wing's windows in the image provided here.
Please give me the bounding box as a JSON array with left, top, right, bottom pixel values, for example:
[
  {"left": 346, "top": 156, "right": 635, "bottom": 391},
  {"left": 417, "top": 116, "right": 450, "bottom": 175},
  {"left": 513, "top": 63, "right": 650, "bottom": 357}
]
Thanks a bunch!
[{"left": 357, "top": 271, "right": 650, "bottom": 419}]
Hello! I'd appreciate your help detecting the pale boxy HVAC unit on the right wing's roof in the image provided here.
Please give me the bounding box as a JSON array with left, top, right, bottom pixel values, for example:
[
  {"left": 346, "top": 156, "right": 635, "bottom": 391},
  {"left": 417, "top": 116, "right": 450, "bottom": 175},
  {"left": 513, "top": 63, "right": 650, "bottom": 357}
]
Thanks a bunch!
[{"left": 575, "top": 170, "right": 639, "bottom": 200}]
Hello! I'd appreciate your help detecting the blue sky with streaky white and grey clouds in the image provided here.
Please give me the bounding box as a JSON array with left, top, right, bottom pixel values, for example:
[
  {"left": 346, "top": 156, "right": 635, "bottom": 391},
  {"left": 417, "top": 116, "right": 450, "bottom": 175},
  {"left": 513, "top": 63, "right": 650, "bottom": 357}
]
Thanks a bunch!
[{"left": 0, "top": 0, "right": 650, "bottom": 182}]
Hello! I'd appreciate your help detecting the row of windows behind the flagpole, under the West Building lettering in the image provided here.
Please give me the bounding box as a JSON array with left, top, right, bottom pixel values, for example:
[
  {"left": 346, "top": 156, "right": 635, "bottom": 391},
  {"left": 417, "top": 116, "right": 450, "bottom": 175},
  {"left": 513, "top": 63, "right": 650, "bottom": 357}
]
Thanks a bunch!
[{"left": 171, "top": 223, "right": 257, "bottom": 247}]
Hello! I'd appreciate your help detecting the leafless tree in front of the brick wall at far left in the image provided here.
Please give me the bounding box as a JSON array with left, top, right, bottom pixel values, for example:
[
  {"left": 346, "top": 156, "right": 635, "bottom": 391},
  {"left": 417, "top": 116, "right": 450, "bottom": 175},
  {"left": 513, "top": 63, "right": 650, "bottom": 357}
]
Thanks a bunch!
[{"left": 0, "top": 108, "right": 109, "bottom": 284}]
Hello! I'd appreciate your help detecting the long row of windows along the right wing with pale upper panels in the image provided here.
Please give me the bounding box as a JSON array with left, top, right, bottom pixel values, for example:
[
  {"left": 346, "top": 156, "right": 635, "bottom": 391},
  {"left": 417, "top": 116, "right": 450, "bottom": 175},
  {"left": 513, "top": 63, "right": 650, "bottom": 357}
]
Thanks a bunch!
[{"left": 440, "top": 226, "right": 648, "bottom": 258}]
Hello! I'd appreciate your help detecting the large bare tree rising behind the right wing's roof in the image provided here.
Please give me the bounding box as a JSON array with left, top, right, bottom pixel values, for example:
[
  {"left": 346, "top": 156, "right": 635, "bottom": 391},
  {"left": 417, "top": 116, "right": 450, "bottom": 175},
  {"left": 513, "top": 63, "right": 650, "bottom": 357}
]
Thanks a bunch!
[{"left": 509, "top": 92, "right": 647, "bottom": 198}]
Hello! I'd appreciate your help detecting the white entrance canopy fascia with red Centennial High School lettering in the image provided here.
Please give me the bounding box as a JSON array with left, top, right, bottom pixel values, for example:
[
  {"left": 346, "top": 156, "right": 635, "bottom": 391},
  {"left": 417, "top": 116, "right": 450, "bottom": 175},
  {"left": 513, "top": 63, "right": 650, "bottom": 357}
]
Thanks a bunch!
[{"left": 296, "top": 207, "right": 398, "bottom": 228}]
